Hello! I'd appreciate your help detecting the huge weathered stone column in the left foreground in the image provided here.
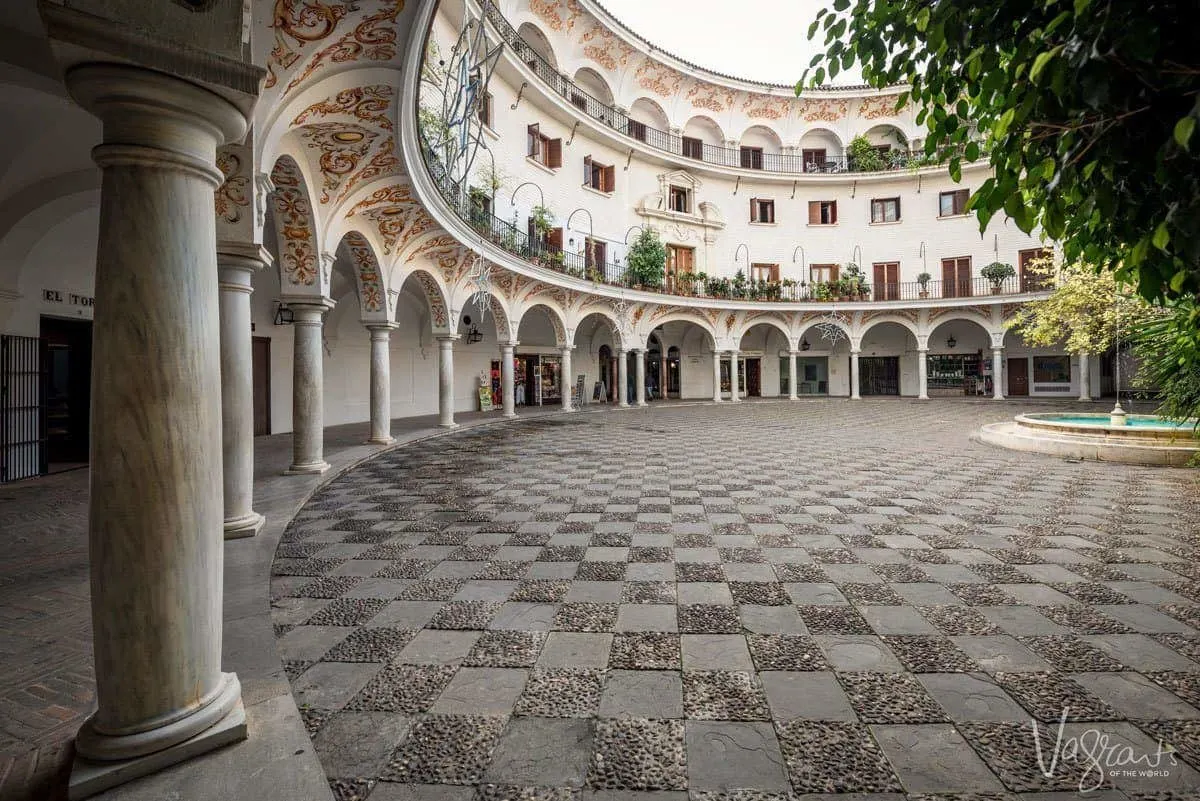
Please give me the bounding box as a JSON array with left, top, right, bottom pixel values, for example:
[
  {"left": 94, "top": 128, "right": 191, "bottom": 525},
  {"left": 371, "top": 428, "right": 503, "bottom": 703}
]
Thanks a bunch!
[{"left": 66, "top": 64, "right": 248, "bottom": 797}]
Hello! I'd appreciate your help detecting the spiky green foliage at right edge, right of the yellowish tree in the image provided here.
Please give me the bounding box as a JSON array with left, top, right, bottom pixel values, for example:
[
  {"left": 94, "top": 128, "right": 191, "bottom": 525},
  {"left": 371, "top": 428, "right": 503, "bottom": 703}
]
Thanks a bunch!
[{"left": 1134, "top": 301, "right": 1200, "bottom": 435}]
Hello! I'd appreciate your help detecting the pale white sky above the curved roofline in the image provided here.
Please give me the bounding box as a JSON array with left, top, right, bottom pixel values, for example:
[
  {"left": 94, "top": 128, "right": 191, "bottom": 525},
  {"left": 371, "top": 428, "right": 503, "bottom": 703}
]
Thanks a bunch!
[{"left": 600, "top": 0, "right": 860, "bottom": 86}]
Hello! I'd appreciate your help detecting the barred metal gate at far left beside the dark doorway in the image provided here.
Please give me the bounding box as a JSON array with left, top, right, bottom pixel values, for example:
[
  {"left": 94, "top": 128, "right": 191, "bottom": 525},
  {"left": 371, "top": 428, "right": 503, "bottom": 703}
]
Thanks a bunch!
[{"left": 0, "top": 335, "right": 47, "bottom": 483}]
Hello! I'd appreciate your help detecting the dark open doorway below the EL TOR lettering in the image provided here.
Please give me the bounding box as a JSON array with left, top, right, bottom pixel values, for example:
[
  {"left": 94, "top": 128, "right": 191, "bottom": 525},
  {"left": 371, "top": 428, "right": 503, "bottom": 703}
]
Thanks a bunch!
[{"left": 42, "top": 317, "right": 91, "bottom": 471}]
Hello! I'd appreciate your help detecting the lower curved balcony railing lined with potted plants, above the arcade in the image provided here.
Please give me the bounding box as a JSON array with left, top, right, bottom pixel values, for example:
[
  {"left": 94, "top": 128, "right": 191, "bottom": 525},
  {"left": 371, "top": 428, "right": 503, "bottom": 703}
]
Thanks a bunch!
[{"left": 421, "top": 137, "right": 1048, "bottom": 303}]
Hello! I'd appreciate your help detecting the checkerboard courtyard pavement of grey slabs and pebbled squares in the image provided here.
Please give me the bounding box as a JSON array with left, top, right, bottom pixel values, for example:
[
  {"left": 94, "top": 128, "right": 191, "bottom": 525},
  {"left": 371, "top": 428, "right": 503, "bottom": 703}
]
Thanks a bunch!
[{"left": 271, "top": 402, "right": 1200, "bottom": 801}]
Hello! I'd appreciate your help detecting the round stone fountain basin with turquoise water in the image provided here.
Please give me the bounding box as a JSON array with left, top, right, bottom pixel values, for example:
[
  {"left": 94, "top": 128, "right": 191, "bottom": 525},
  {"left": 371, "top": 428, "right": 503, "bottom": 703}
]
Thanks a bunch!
[{"left": 973, "top": 414, "right": 1200, "bottom": 466}]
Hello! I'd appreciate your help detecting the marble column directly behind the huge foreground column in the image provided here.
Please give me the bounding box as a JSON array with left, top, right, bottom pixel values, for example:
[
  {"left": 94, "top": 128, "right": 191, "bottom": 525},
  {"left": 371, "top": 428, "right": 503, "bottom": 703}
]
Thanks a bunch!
[{"left": 217, "top": 242, "right": 271, "bottom": 540}]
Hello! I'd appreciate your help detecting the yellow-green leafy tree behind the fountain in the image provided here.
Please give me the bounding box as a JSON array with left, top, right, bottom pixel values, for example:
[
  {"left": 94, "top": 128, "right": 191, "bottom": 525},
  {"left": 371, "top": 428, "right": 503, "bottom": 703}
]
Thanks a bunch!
[{"left": 1007, "top": 259, "right": 1162, "bottom": 354}]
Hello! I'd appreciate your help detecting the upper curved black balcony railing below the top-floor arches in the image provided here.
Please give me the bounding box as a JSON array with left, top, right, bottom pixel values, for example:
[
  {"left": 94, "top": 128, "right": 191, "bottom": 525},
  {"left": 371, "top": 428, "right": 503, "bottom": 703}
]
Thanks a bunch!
[{"left": 481, "top": 0, "right": 938, "bottom": 174}]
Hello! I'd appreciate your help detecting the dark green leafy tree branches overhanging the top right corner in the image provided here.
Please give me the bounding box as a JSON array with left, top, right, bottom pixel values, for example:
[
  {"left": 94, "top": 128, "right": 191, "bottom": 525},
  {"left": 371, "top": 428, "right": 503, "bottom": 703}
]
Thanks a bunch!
[{"left": 796, "top": 0, "right": 1200, "bottom": 306}]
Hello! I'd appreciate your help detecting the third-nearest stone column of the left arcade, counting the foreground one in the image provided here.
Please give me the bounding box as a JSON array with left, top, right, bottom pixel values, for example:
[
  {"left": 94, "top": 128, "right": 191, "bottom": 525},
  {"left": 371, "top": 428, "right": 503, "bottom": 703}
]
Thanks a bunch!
[{"left": 284, "top": 297, "right": 334, "bottom": 476}]
